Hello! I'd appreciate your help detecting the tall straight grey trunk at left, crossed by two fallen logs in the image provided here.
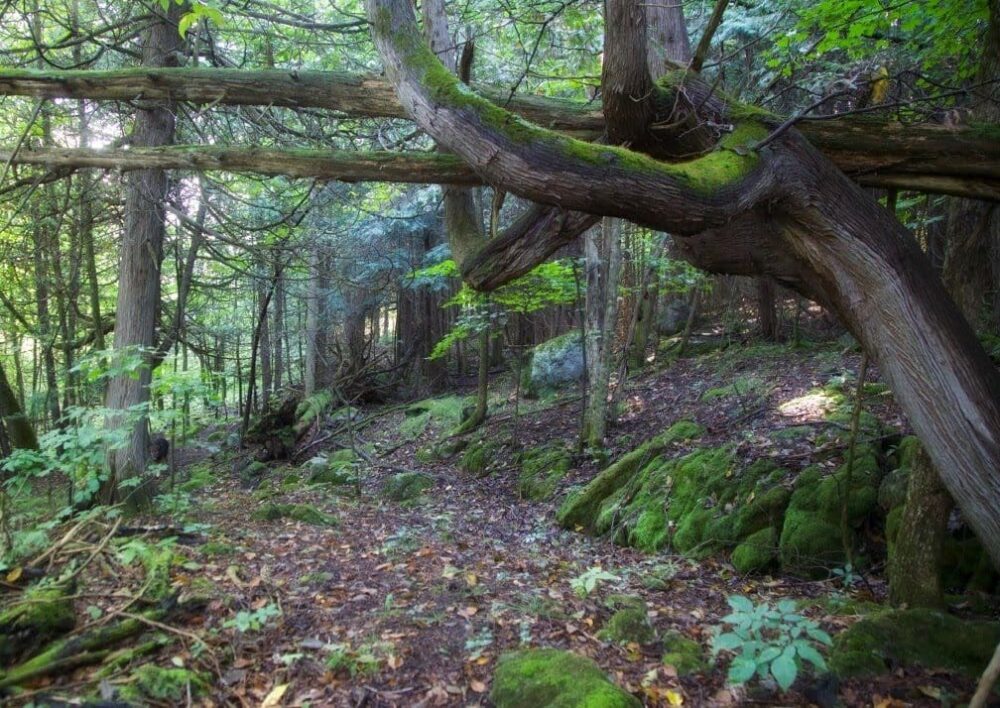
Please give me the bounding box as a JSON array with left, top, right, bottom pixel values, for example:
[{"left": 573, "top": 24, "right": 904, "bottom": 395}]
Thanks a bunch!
[{"left": 101, "top": 3, "right": 182, "bottom": 508}]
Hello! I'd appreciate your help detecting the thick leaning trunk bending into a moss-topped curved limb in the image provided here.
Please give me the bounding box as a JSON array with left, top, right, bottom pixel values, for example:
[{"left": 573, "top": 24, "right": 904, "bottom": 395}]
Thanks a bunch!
[{"left": 368, "top": 0, "right": 1000, "bottom": 565}]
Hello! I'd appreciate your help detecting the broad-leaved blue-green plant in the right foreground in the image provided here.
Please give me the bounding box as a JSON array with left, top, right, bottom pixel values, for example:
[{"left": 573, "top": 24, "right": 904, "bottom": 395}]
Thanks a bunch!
[{"left": 712, "top": 595, "right": 833, "bottom": 691}]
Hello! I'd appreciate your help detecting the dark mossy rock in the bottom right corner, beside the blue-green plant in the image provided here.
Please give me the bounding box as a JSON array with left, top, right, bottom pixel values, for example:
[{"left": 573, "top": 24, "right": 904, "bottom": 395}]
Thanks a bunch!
[{"left": 829, "top": 610, "right": 1000, "bottom": 678}]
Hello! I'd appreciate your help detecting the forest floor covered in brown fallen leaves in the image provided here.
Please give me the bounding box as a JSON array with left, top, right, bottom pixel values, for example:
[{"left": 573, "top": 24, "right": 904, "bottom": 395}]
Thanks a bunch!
[{"left": 11, "top": 334, "right": 996, "bottom": 708}]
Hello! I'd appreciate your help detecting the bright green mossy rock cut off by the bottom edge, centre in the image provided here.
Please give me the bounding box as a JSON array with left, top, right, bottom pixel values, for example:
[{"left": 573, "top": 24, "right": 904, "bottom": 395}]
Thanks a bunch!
[{"left": 490, "top": 649, "right": 642, "bottom": 708}]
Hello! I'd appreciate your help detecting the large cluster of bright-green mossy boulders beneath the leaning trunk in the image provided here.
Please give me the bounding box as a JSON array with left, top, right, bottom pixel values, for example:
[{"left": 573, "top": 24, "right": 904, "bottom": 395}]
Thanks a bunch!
[{"left": 558, "top": 411, "right": 896, "bottom": 575}]
